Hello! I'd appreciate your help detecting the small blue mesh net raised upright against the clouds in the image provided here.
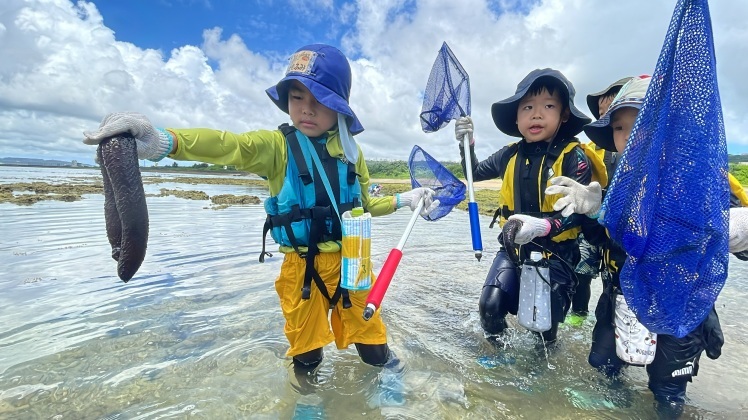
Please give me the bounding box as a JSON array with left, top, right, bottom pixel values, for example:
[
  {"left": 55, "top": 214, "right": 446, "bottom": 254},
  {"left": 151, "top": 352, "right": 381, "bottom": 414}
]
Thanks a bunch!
[{"left": 421, "top": 42, "right": 470, "bottom": 133}]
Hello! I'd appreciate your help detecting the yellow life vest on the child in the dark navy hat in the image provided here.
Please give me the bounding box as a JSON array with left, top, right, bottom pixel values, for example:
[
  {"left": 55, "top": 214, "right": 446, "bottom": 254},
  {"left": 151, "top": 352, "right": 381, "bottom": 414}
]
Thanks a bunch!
[{"left": 496, "top": 139, "right": 596, "bottom": 242}]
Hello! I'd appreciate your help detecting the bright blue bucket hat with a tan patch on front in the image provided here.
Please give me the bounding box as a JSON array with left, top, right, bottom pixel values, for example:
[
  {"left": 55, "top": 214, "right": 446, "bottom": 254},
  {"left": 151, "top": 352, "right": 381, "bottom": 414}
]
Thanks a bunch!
[{"left": 265, "top": 44, "right": 364, "bottom": 135}]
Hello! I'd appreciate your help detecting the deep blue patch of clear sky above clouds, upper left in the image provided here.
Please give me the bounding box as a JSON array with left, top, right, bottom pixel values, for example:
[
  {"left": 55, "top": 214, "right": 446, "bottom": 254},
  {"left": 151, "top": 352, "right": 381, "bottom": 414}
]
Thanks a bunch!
[{"left": 94, "top": 0, "right": 348, "bottom": 56}]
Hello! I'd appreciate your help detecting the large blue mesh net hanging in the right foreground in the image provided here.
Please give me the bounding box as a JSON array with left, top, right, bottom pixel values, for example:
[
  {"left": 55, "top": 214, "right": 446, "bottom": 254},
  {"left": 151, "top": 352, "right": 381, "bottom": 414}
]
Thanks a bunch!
[{"left": 601, "top": 0, "right": 730, "bottom": 337}]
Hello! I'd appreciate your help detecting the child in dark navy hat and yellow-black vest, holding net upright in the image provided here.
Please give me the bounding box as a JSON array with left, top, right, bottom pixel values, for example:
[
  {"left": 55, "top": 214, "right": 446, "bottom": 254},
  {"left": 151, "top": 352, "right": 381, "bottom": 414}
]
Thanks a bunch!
[{"left": 455, "top": 68, "right": 592, "bottom": 343}]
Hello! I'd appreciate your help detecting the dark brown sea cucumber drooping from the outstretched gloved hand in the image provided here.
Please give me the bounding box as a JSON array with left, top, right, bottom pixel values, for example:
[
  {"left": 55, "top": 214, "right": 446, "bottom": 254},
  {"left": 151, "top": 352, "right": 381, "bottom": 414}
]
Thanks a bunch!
[{"left": 96, "top": 134, "right": 148, "bottom": 283}]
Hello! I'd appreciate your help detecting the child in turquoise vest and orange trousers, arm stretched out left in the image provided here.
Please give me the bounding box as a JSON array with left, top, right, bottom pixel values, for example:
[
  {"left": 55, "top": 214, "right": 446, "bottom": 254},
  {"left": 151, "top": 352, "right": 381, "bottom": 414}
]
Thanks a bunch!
[{"left": 84, "top": 44, "right": 438, "bottom": 398}]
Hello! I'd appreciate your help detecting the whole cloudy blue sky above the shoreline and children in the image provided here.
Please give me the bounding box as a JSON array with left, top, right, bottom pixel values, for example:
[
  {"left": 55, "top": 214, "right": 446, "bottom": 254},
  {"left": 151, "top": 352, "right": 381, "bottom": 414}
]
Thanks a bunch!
[{"left": 0, "top": 0, "right": 748, "bottom": 163}]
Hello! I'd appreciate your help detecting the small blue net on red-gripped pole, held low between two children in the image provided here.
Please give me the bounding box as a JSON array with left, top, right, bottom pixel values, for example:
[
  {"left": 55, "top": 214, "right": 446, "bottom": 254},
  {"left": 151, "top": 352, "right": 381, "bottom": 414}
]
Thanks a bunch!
[{"left": 408, "top": 146, "right": 465, "bottom": 222}]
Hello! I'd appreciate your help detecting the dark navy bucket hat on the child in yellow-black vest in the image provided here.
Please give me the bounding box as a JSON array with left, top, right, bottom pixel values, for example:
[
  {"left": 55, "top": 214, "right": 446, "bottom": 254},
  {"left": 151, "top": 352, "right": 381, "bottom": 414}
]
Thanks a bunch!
[{"left": 491, "top": 69, "right": 592, "bottom": 138}]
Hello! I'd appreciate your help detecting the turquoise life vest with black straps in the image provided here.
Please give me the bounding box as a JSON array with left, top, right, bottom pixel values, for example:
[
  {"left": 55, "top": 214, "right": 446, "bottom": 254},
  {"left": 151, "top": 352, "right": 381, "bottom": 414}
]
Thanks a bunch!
[{"left": 260, "top": 124, "right": 361, "bottom": 261}]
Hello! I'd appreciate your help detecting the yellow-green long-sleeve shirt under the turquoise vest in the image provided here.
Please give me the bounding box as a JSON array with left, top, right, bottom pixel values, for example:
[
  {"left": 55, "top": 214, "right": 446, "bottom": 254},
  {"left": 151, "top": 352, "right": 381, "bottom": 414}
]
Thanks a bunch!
[{"left": 168, "top": 128, "right": 396, "bottom": 252}]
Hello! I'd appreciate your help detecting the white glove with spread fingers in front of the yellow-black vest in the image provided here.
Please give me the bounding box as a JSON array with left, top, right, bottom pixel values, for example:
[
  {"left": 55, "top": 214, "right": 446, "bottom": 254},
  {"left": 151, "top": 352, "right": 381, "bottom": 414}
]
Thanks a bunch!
[{"left": 545, "top": 176, "right": 603, "bottom": 217}]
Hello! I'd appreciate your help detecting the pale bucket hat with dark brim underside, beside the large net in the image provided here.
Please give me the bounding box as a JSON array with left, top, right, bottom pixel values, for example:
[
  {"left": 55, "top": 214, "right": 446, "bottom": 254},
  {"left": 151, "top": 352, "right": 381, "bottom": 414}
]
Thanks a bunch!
[{"left": 584, "top": 76, "right": 652, "bottom": 152}]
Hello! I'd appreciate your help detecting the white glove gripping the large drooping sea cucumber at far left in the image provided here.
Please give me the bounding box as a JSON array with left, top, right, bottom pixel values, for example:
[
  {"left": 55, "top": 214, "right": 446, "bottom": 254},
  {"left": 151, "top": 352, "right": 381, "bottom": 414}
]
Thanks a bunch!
[{"left": 83, "top": 112, "right": 173, "bottom": 162}]
